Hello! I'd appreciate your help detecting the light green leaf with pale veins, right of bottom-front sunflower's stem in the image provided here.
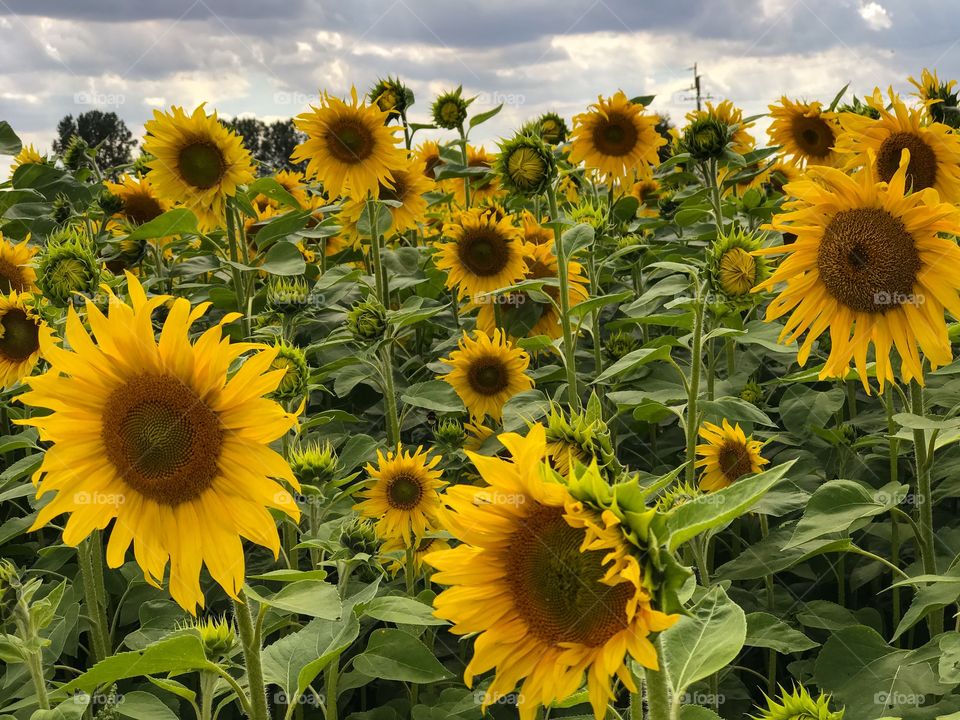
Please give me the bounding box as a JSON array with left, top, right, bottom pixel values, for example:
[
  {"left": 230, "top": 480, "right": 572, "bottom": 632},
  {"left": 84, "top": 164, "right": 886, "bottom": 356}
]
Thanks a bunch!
[{"left": 660, "top": 585, "right": 747, "bottom": 695}]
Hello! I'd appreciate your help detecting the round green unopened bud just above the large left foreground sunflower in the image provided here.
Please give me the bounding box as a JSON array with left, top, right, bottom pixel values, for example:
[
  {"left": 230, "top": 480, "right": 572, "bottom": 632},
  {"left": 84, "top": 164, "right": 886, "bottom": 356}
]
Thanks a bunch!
[{"left": 37, "top": 230, "right": 100, "bottom": 307}]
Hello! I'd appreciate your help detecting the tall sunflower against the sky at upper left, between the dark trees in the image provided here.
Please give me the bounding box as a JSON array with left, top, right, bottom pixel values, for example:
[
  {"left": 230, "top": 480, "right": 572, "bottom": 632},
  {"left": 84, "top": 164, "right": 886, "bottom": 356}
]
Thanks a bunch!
[{"left": 143, "top": 104, "right": 254, "bottom": 230}]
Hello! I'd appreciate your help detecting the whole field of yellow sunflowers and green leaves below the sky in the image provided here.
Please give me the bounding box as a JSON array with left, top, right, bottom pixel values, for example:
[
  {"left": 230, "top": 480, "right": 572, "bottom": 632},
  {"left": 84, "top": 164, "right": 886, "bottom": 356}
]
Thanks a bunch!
[{"left": 0, "top": 70, "right": 960, "bottom": 720}]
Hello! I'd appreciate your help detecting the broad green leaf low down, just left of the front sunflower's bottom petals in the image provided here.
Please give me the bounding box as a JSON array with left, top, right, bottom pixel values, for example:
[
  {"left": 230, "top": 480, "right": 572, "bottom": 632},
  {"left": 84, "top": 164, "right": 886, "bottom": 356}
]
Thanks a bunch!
[{"left": 353, "top": 629, "right": 452, "bottom": 683}]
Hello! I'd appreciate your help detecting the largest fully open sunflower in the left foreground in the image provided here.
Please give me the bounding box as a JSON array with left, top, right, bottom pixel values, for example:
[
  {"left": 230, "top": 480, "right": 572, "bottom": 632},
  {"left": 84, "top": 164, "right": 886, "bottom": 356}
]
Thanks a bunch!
[{"left": 20, "top": 273, "right": 300, "bottom": 614}]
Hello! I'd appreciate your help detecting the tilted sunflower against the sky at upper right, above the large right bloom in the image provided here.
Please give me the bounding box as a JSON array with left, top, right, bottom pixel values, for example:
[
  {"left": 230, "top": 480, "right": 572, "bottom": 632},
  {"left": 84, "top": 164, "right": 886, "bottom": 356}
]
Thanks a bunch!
[{"left": 767, "top": 96, "right": 840, "bottom": 167}]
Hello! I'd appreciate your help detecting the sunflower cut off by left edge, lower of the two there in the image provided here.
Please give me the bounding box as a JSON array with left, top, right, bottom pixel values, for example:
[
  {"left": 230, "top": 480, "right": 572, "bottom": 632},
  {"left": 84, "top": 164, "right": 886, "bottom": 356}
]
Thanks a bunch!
[{"left": 0, "top": 290, "right": 53, "bottom": 389}]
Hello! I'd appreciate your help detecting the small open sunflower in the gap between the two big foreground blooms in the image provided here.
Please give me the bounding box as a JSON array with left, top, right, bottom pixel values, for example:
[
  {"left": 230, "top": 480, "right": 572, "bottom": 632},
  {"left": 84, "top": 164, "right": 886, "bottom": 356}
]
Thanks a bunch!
[{"left": 354, "top": 447, "right": 444, "bottom": 545}]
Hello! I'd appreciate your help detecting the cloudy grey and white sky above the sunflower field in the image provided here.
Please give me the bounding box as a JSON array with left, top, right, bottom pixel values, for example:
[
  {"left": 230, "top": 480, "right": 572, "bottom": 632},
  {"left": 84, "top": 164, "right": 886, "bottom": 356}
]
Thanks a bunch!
[{"left": 0, "top": 0, "right": 960, "bottom": 160}]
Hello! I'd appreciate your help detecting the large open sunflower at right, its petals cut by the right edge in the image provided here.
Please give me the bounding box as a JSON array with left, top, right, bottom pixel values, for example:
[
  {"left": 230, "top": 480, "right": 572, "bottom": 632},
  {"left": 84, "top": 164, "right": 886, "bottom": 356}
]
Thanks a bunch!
[{"left": 754, "top": 150, "right": 960, "bottom": 392}]
